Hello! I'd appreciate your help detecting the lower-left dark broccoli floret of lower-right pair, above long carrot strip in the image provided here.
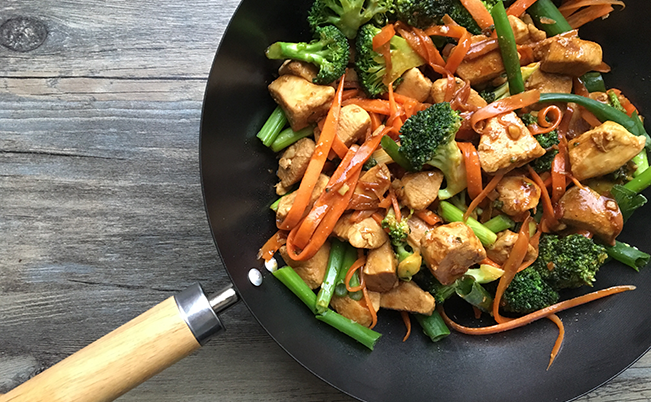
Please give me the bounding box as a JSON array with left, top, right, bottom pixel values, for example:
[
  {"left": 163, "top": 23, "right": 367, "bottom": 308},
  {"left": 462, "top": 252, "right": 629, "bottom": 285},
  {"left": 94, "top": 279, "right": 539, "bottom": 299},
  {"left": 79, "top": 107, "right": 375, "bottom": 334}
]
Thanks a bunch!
[{"left": 502, "top": 267, "right": 559, "bottom": 314}]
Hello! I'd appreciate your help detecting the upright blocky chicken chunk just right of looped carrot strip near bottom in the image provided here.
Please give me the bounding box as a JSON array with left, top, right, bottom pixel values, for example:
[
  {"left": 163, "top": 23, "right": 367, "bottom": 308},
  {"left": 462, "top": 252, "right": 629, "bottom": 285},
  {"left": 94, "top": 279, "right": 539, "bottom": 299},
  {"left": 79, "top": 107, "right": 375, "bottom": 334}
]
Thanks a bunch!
[{"left": 362, "top": 242, "right": 398, "bottom": 292}]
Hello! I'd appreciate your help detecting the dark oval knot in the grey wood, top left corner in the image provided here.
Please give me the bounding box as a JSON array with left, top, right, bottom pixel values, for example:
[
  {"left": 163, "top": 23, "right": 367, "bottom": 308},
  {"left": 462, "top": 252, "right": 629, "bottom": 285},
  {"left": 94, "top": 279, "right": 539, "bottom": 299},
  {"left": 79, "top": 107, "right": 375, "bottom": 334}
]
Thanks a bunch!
[{"left": 0, "top": 17, "right": 48, "bottom": 52}]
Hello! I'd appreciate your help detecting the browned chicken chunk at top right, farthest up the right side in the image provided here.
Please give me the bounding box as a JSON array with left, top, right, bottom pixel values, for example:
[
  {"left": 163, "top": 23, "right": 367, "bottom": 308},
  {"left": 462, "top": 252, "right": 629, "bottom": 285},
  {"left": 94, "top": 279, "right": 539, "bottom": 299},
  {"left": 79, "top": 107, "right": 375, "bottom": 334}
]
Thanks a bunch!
[{"left": 534, "top": 35, "right": 603, "bottom": 77}]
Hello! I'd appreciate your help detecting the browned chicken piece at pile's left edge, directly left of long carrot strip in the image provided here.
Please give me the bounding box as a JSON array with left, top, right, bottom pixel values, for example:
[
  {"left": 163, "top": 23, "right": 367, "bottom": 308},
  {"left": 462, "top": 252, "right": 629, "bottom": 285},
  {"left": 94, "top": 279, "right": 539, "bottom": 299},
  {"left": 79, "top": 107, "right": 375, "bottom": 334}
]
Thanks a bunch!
[{"left": 276, "top": 138, "right": 316, "bottom": 195}]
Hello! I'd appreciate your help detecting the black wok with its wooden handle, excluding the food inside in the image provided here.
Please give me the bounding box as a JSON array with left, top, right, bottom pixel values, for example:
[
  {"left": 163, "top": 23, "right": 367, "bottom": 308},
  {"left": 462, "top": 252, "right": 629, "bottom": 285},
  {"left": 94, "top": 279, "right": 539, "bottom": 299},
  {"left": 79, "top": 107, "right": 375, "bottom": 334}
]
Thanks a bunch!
[{"left": 0, "top": 0, "right": 651, "bottom": 402}]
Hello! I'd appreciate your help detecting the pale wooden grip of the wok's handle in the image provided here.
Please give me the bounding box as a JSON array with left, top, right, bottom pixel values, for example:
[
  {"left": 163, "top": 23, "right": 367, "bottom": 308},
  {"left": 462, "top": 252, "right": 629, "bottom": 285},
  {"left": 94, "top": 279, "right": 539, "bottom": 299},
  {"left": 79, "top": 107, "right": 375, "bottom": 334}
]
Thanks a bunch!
[{"left": 0, "top": 297, "right": 200, "bottom": 402}]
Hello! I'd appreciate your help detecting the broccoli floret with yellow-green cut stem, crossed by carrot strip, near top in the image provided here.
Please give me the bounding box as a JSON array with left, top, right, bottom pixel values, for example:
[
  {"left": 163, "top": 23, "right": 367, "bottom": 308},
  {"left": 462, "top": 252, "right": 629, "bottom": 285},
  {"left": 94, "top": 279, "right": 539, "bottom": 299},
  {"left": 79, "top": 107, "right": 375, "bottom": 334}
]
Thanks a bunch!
[{"left": 355, "top": 24, "right": 425, "bottom": 98}]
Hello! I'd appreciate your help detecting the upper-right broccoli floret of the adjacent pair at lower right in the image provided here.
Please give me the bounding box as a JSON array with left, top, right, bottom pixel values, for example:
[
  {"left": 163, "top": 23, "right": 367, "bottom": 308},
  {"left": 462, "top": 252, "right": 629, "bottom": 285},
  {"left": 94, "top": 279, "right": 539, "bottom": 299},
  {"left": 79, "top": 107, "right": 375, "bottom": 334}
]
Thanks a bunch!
[{"left": 523, "top": 234, "right": 608, "bottom": 290}]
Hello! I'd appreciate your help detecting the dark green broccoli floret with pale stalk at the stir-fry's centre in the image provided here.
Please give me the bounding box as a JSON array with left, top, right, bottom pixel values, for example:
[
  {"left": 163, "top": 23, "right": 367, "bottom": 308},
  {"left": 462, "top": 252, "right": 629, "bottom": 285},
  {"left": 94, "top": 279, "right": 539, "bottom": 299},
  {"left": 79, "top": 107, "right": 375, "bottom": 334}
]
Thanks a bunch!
[{"left": 400, "top": 102, "right": 467, "bottom": 200}]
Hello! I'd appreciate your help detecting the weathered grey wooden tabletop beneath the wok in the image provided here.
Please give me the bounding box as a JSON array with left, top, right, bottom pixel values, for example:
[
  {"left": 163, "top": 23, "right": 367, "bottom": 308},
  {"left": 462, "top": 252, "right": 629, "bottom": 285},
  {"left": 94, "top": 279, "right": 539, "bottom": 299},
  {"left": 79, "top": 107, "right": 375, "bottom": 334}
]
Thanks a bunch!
[{"left": 0, "top": 0, "right": 651, "bottom": 402}]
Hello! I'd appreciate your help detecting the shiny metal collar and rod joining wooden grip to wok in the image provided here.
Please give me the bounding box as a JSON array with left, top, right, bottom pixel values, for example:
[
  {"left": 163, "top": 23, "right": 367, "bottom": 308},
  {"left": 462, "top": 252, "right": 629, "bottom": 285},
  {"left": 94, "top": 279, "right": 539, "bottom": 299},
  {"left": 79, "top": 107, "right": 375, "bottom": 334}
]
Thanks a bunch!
[{"left": 174, "top": 283, "right": 238, "bottom": 345}]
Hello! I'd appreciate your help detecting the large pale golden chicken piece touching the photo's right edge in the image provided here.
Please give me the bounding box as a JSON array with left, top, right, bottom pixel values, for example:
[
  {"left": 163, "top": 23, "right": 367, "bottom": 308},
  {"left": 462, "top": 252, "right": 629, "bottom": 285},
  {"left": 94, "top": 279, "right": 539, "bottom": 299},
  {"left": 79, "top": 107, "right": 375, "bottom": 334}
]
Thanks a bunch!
[{"left": 568, "top": 121, "right": 646, "bottom": 181}]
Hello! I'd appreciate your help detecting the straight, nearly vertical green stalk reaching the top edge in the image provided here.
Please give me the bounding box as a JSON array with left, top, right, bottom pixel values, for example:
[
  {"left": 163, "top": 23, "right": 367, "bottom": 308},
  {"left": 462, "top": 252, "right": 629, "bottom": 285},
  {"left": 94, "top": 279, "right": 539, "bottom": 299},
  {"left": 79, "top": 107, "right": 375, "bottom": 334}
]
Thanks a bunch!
[{"left": 491, "top": 1, "right": 524, "bottom": 95}]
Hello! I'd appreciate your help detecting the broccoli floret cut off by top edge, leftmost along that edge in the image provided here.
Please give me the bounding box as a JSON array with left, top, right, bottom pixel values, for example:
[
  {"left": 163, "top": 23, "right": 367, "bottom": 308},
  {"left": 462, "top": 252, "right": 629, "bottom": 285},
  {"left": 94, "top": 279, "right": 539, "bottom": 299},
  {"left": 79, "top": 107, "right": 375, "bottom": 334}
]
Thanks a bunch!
[{"left": 307, "top": 0, "right": 393, "bottom": 39}]
